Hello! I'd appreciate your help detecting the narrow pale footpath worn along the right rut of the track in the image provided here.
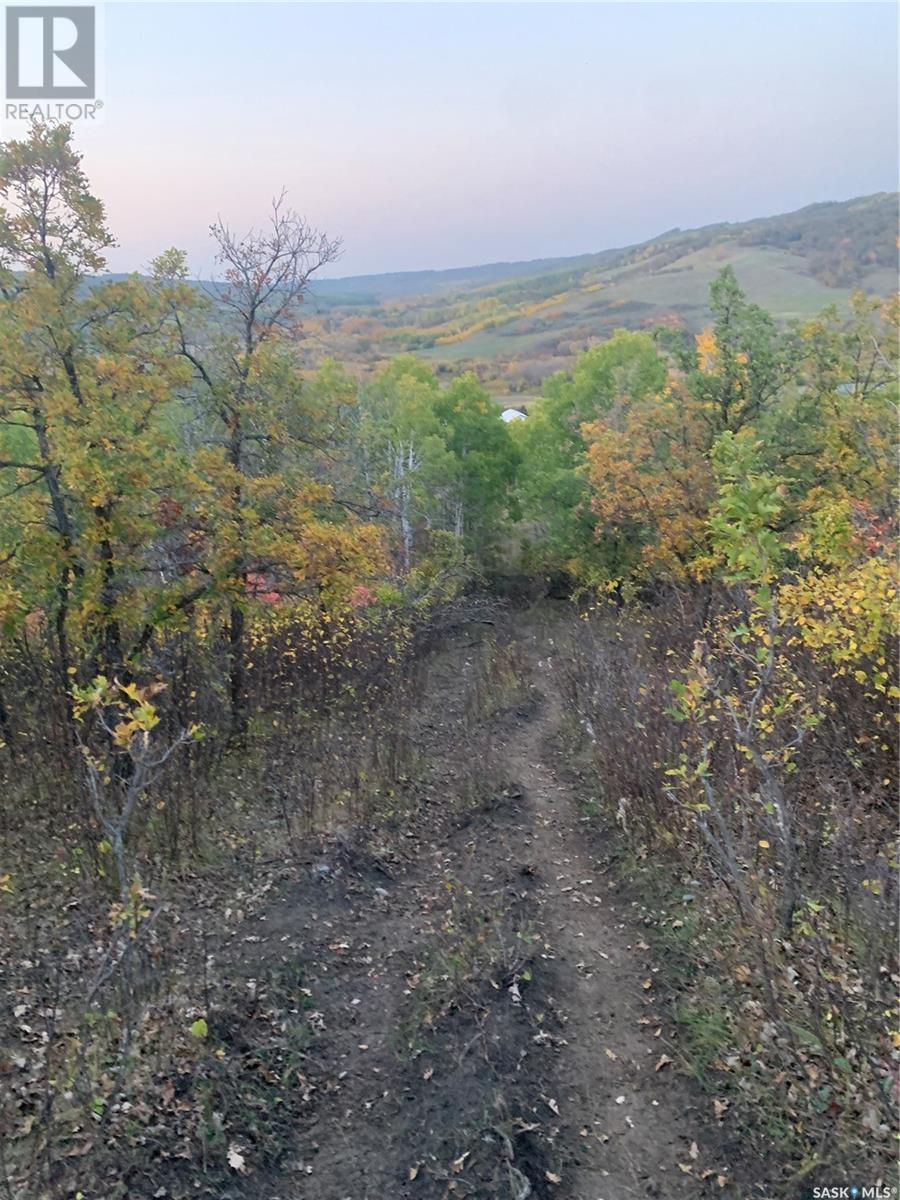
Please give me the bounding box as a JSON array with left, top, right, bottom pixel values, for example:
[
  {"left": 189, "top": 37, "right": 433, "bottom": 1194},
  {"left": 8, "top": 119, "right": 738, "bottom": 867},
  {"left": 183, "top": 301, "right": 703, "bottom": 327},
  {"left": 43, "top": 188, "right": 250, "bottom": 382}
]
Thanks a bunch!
[{"left": 508, "top": 644, "right": 710, "bottom": 1200}]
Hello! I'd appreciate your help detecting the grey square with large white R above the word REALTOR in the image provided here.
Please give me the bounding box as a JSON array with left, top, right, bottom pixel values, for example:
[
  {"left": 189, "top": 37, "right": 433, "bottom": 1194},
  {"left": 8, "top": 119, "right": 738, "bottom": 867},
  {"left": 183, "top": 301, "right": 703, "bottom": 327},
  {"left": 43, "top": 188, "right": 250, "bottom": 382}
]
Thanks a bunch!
[{"left": 6, "top": 5, "right": 96, "bottom": 100}]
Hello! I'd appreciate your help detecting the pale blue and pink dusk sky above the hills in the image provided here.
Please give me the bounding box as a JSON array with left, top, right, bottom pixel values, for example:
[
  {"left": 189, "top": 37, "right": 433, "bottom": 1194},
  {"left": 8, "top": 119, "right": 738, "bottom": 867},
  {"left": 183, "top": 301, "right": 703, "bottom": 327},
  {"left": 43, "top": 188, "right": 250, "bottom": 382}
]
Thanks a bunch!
[{"left": 66, "top": 2, "right": 898, "bottom": 276}]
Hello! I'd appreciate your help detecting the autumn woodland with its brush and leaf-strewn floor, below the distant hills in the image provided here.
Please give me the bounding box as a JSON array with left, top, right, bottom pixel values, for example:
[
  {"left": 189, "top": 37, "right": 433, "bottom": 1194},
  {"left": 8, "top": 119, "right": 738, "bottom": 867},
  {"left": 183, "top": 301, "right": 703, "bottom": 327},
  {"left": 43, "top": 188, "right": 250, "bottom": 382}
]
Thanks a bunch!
[{"left": 0, "top": 125, "right": 900, "bottom": 1200}]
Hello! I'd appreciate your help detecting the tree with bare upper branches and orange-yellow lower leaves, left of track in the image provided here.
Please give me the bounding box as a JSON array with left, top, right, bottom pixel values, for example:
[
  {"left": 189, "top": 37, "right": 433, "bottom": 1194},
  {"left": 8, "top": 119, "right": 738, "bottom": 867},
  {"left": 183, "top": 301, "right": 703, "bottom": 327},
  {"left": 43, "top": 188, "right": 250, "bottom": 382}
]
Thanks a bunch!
[{"left": 155, "top": 194, "right": 379, "bottom": 734}]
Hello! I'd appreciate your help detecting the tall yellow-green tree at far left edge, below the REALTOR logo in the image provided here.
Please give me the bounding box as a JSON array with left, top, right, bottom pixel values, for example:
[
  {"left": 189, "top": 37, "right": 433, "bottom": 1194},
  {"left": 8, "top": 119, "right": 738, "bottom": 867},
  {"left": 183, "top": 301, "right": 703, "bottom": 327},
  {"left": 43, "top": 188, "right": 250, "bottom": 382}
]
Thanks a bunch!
[{"left": 0, "top": 124, "right": 193, "bottom": 696}]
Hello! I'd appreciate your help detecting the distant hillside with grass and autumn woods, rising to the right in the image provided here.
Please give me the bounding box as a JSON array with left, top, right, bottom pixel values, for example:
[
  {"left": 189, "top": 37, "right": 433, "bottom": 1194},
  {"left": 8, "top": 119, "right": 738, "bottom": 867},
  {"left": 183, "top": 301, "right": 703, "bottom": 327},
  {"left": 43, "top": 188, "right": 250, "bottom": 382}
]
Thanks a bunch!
[{"left": 301, "top": 192, "right": 898, "bottom": 390}]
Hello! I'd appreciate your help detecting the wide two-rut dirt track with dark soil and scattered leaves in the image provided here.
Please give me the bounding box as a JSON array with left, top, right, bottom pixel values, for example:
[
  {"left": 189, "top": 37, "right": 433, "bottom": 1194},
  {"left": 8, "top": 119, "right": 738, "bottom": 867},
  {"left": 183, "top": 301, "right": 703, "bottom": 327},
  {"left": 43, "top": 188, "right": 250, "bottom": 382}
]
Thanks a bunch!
[{"left": 229, "top": 624, "right": 727, "bottom": 1200}]
